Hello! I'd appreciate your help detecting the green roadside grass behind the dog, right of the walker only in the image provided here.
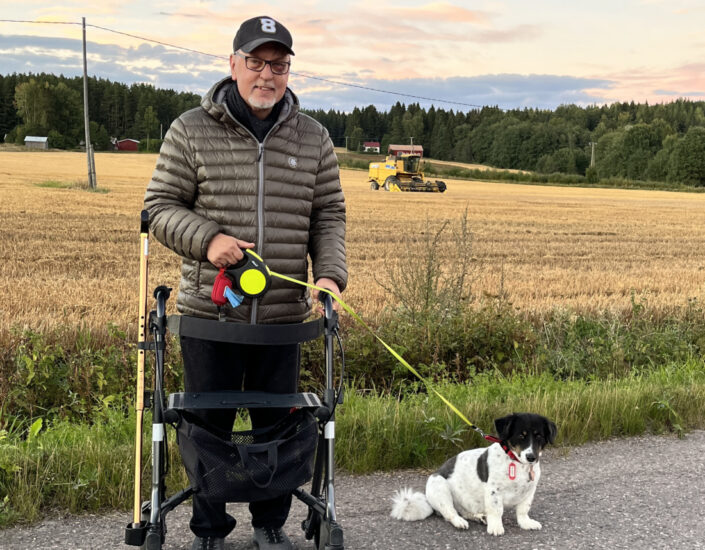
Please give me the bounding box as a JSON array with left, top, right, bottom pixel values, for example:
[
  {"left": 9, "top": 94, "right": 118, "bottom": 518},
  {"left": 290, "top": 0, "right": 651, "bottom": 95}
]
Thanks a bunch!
[{"left": 336, "top": 360, "right": 705, "bottom": 473}]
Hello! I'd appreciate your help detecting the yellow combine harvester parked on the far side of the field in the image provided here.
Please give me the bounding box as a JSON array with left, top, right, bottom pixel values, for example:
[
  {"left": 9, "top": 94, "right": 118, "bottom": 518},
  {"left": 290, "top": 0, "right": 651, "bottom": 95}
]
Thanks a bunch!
[{"left": 370, "top": 153, "right": 446, "bottom": 193}]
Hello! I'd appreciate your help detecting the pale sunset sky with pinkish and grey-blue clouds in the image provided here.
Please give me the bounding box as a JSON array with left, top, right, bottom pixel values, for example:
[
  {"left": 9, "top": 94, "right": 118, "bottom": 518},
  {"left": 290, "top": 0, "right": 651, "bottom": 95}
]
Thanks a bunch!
[{"left": 0, "top": 0, "right": 705, "bottom": 112}]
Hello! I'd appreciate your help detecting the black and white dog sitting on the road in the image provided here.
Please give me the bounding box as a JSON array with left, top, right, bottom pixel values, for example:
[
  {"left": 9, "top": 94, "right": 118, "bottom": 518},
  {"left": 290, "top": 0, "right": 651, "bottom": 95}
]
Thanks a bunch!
[{"left": 391, "top": 413, "right": 557, "bottom": 535}]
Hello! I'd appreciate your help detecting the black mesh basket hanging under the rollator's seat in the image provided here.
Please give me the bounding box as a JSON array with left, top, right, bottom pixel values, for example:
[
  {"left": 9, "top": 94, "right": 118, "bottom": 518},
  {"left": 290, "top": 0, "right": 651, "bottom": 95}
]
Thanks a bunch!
[{"left": 177, "top": 409, "right": 318, "bottom": 502}]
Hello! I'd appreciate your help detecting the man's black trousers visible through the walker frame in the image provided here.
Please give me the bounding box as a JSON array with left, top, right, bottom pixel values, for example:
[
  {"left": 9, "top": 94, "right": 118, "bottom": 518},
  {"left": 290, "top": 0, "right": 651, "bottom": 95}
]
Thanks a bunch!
[{"left": 181, "top": 336, "right": 301, "bottom": 537}]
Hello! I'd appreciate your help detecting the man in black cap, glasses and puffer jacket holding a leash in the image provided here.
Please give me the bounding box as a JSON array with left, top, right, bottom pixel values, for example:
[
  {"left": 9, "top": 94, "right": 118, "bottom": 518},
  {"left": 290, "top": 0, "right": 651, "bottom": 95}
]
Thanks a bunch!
[{"left": 145, "top": 16, "right": 347, "bottom": 550}]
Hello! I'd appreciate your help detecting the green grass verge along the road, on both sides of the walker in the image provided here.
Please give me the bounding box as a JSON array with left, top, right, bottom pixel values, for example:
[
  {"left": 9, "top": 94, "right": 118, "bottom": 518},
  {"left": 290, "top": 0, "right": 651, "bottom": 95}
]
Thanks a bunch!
[{"left": 0, "top": 360, "right": 705, "bottom": 527}]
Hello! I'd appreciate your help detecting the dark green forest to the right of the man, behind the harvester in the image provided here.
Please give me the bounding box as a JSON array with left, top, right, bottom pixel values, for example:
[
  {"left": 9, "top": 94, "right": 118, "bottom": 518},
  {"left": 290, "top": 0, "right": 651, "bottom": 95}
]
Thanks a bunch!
[{"left": 309, "top": 99, "right": 705, "bottom": 185}]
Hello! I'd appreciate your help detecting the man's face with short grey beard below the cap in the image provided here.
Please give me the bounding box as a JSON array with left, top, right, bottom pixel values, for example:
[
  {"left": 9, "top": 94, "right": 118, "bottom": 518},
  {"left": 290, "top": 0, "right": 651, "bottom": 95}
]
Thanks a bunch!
[{"left": 230, "top": 43, "right": 290, "bottom": 119}]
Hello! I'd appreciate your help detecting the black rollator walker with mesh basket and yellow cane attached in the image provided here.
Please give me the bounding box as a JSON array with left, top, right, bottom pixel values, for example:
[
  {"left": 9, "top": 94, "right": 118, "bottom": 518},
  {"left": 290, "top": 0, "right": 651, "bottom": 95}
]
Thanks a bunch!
[{"left": 125, "top": 211, "right": 345, "bottom": 550}]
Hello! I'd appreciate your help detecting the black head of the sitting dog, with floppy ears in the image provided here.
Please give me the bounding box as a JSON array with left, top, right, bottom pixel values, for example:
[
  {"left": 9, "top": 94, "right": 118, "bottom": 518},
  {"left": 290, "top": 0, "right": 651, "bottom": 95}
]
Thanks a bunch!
[{"left": 494, "top": 413, "right": 558, "bottom": 462}]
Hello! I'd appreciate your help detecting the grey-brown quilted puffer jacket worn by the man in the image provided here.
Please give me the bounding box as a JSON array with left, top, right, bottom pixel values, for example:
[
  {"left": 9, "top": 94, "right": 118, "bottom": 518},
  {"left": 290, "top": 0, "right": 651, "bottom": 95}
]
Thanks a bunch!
[{"left": 144, "top": 78, "right": 347, "bottom": 323}]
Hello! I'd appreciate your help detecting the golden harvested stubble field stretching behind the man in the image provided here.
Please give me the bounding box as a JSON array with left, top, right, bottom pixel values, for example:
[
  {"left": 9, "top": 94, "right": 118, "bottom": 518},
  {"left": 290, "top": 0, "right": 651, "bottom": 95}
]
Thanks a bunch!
[{"left": 0, "top": 150, "right": 705, "bottom": 337}]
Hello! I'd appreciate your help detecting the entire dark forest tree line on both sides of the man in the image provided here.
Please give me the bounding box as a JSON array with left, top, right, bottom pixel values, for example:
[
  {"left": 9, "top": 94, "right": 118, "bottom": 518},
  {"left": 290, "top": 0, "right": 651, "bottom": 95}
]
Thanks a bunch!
[{"left": 0, "top": 74, "right": 705, "bottom": 185}]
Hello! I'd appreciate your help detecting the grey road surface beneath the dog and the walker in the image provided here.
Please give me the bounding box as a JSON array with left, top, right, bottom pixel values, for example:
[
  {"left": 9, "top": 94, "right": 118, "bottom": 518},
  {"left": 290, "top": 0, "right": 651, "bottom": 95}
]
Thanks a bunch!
[{"left": 0, "top": 431, "right": 705, "bottom": 550}]
